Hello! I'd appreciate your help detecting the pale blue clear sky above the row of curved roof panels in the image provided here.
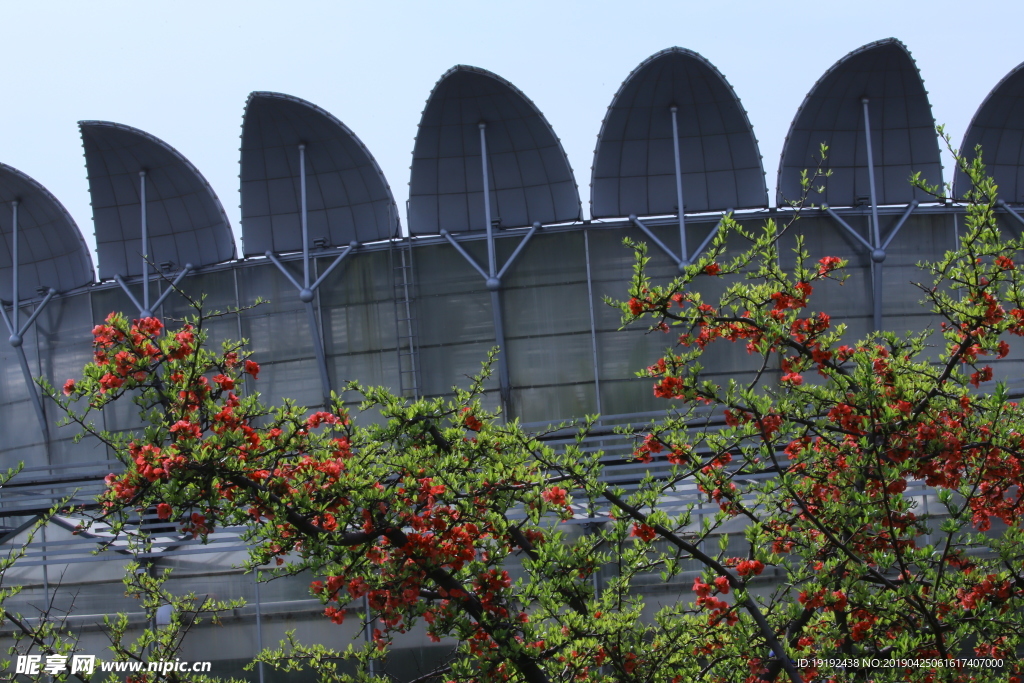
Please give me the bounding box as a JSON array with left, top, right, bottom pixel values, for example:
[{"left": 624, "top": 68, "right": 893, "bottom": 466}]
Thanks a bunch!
[{"left": 0, "top": 0, "right": 1024, "bottom": 259}]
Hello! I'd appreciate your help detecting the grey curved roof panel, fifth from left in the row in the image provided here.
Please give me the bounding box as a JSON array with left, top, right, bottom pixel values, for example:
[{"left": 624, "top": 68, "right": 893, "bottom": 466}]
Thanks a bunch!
[{"left": 590, "top": 47, "right": 768, "bottom": 218}]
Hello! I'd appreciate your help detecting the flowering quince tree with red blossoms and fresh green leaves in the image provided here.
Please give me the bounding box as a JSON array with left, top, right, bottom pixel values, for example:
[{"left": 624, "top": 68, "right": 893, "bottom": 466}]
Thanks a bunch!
[{"left": 46, "top": 145, "right": 1024, "bottom": 683}]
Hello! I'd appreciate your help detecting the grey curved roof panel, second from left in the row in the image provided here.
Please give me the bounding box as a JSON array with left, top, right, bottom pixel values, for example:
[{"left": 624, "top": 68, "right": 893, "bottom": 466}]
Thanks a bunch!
[{"left": 78, "top": 121, "right": 234, "bottom": 280}]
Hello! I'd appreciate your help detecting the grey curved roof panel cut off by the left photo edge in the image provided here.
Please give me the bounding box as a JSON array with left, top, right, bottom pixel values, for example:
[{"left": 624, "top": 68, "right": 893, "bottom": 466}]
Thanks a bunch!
[{"left": 0, "top": 164, "right": 93, "bottom": 301}]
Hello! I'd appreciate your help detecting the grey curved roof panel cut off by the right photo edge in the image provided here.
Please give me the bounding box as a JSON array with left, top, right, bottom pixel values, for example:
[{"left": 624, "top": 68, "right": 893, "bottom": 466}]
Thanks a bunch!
[{"left": 953, "top": 63, "right": 1024, "bottom": 204}]
